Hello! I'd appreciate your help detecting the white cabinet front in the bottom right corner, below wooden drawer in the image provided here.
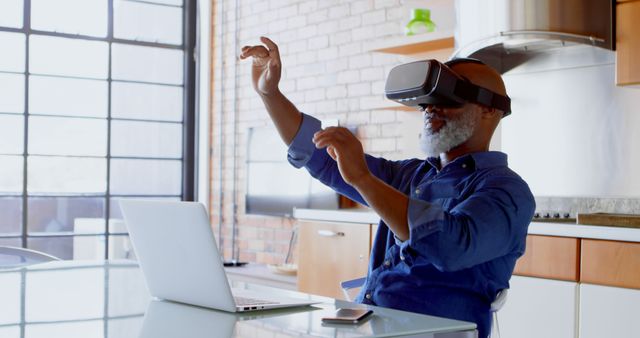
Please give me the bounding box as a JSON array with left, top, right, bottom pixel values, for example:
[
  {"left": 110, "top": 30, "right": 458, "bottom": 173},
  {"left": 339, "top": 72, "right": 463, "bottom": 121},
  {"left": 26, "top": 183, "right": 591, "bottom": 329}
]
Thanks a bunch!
[{"left": 579, "top": 284, "right": 640, "bottom": 338}]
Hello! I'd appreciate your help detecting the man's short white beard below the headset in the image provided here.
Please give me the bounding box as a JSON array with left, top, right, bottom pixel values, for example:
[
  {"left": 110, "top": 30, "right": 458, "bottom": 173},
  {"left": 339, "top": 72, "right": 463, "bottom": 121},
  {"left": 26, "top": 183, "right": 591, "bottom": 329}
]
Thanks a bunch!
[{"left": 420, "top": 111, "right": 476, "bottom": 157}]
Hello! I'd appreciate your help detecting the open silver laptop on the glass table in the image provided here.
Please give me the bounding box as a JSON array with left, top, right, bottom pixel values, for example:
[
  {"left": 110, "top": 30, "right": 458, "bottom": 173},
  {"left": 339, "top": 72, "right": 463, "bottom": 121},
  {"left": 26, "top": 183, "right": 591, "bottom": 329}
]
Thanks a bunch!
[{"left": 120, "top": 200, "right": 318, "bottom": 312}]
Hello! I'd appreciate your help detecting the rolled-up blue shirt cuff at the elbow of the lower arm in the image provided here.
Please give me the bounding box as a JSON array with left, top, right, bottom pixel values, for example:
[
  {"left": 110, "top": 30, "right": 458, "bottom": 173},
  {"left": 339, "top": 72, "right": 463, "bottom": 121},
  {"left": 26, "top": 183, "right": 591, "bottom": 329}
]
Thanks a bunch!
[{"left": 396, "top": 198, "right": 444, "bottom": 247}]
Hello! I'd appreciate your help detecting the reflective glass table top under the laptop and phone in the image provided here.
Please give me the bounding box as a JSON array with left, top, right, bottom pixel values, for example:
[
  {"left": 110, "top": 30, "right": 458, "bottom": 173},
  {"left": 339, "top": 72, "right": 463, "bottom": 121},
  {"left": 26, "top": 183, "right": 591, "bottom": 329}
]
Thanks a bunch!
[{"left": 0, "top": 261, "right": 475, "bottom": 338}]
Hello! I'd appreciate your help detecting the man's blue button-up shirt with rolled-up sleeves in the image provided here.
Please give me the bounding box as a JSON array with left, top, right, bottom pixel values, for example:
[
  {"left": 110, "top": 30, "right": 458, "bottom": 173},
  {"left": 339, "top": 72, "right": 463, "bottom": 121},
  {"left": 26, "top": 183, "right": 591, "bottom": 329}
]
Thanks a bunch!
[{"left": 288, "top": 114, "right": 535, "bottom": 337}]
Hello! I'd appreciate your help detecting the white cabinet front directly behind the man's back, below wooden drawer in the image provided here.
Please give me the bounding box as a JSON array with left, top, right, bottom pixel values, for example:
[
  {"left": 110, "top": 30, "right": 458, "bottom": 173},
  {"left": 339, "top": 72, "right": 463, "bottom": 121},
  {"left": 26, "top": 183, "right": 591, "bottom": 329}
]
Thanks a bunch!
[{"left": 498, "top": 276, "right": 578, "bottom": 338}]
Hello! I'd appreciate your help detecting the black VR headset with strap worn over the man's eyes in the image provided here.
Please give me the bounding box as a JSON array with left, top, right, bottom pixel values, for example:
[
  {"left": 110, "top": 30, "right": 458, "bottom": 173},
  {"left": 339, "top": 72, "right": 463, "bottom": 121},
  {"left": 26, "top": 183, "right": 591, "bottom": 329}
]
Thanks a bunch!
[{"left": 384, "top": 59, "right": 511, "bottom": 117}]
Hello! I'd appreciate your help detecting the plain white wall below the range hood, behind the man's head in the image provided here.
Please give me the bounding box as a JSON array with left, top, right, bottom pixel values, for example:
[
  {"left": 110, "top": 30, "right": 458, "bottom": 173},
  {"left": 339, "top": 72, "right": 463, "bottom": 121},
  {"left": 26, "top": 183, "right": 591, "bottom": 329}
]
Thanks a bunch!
[{"left": 501, "top": 47, "right": 640, "bottom": 197}]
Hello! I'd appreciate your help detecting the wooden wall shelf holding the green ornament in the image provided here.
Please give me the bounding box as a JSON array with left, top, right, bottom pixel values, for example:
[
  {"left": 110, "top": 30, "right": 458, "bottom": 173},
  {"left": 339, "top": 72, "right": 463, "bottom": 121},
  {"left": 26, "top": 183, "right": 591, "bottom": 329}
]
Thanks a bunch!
[{"left": 368, "top": 31, "right": 454, "bottom": 56}]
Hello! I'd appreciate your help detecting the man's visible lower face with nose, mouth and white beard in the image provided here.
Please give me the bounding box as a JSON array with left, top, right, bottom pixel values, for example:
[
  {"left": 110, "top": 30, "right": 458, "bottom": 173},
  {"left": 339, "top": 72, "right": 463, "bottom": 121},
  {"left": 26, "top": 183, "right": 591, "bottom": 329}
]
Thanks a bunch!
[{"left": 420, "top": 103, "right": 476, "bottom": 157}]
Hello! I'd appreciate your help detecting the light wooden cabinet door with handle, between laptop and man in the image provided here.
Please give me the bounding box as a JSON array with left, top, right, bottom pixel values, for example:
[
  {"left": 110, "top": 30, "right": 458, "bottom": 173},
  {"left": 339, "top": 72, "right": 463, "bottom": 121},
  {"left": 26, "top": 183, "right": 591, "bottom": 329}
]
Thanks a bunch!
[{"left": 298, "top": 222, "right": 371, "bottom": 299}]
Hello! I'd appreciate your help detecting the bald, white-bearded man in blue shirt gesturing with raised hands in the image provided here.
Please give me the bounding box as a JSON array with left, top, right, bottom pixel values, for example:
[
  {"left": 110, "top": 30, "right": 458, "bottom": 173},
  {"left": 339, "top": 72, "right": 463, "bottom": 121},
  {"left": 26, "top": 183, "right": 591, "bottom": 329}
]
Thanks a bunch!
[{"left": 240, "top": 37, "right": 535, "bottom": 337}]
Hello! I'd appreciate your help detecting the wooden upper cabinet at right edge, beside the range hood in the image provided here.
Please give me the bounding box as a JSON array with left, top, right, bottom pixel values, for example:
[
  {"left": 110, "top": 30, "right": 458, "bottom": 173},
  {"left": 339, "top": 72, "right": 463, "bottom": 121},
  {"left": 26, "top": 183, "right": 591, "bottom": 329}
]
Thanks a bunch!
[{"left": 616, "top": 0, "right": 640, "bottom": 86}]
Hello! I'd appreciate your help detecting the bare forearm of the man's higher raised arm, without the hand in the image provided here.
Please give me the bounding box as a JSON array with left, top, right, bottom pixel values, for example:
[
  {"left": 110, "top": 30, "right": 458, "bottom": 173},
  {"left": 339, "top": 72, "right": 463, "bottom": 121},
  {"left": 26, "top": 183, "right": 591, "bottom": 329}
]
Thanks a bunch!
[{"left": 260, "top": 91, "right": 302, "bottom": 146}]
